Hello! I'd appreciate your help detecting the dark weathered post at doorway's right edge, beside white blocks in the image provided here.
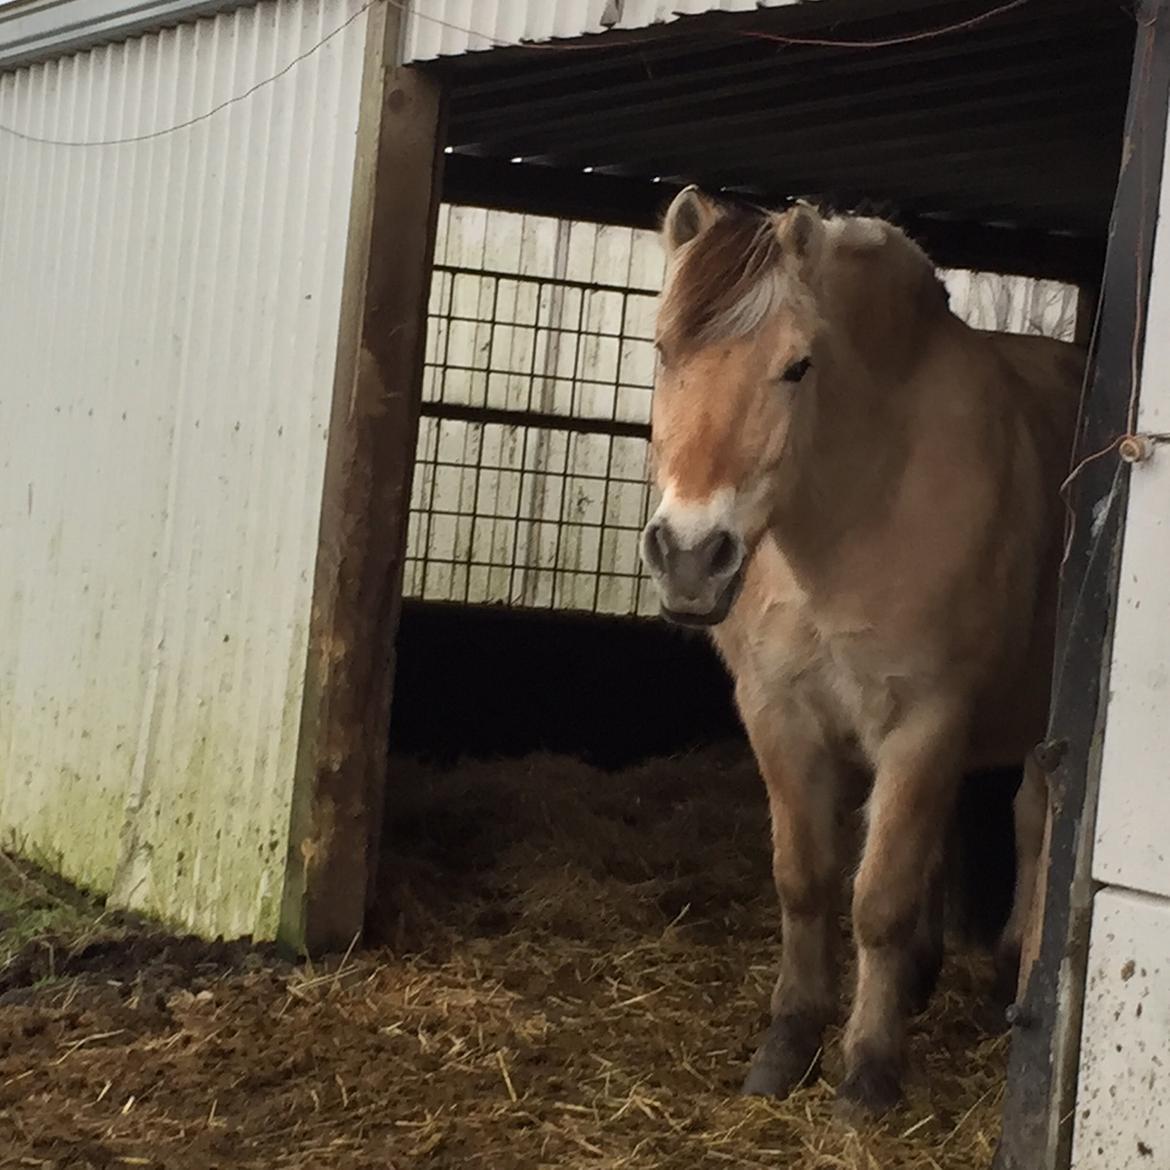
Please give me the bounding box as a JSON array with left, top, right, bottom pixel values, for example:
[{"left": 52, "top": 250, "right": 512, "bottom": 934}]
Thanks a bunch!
[{"left": 995, "top": 0, "right": 1170, "bottom": 1170}]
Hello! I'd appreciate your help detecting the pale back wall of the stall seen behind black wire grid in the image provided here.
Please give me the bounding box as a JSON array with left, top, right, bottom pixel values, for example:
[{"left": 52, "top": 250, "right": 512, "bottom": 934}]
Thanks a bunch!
[{"left": 405, "top": 207, "right": 1076, "bottom": 614}]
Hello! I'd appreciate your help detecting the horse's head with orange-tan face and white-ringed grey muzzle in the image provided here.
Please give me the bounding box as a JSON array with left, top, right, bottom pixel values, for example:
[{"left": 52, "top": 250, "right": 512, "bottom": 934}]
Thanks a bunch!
[{"left": 642, "top": 187, "right": 825, "bottom": 625}]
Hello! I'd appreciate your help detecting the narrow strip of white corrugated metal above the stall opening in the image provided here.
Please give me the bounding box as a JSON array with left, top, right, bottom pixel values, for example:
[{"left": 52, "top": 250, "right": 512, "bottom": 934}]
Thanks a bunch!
[{"left": 405, "top": 0, "right": 817, "bottom": 63}]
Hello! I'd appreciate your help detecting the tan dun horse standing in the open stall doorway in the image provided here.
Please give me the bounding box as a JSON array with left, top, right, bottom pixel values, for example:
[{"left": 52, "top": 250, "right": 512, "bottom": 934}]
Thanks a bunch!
[{"left": 640, "top": 187, "right": 1086, "bottom": 1117}]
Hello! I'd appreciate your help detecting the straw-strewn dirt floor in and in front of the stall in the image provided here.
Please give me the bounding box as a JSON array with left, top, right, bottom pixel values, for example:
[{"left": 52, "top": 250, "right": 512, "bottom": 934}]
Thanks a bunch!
[{"left": 0, "top": 753, "right": 1006, "bottom": 1170}]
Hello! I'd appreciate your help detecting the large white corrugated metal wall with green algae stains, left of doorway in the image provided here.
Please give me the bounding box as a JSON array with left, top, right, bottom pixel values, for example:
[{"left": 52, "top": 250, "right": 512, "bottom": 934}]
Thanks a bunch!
[{"left": 0, "top": 0, "right": 365, "bottom": 937}]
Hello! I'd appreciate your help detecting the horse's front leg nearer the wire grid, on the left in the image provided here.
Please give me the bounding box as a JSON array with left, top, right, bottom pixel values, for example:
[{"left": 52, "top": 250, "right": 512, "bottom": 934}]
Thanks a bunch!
[{"left": 744, "top": 711, "right": 840, "bottom": 1096}]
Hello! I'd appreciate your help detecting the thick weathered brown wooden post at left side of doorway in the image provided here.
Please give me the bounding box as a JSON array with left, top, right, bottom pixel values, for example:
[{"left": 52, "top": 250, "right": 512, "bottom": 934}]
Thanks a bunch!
[{"left": 281, "top": 5, "right": 443, "bottom": 951}]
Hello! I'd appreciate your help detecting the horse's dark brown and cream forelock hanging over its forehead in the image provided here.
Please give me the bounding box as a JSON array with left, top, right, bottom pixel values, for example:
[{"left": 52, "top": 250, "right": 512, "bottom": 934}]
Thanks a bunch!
[{"left": 659, "top": 213, "right": 783, "bottom": 350}]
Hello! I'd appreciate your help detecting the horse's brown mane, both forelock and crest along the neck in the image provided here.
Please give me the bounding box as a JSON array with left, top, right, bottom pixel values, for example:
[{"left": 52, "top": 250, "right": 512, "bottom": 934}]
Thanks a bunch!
[{"left": 658, "top": 201, "right": 947, "bottom": 351}]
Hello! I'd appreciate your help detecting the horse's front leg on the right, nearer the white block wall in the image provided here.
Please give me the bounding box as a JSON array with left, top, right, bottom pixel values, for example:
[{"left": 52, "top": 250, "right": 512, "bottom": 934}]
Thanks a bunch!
[{"left": 838, "top": 703, "right": 965, "bottom": 1114}]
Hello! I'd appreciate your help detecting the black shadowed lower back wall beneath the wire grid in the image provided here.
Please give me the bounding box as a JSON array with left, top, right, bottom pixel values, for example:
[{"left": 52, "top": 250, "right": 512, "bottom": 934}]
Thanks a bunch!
[{"left": 391, "top": 601, "right": 1019, "bottom": 944}]
